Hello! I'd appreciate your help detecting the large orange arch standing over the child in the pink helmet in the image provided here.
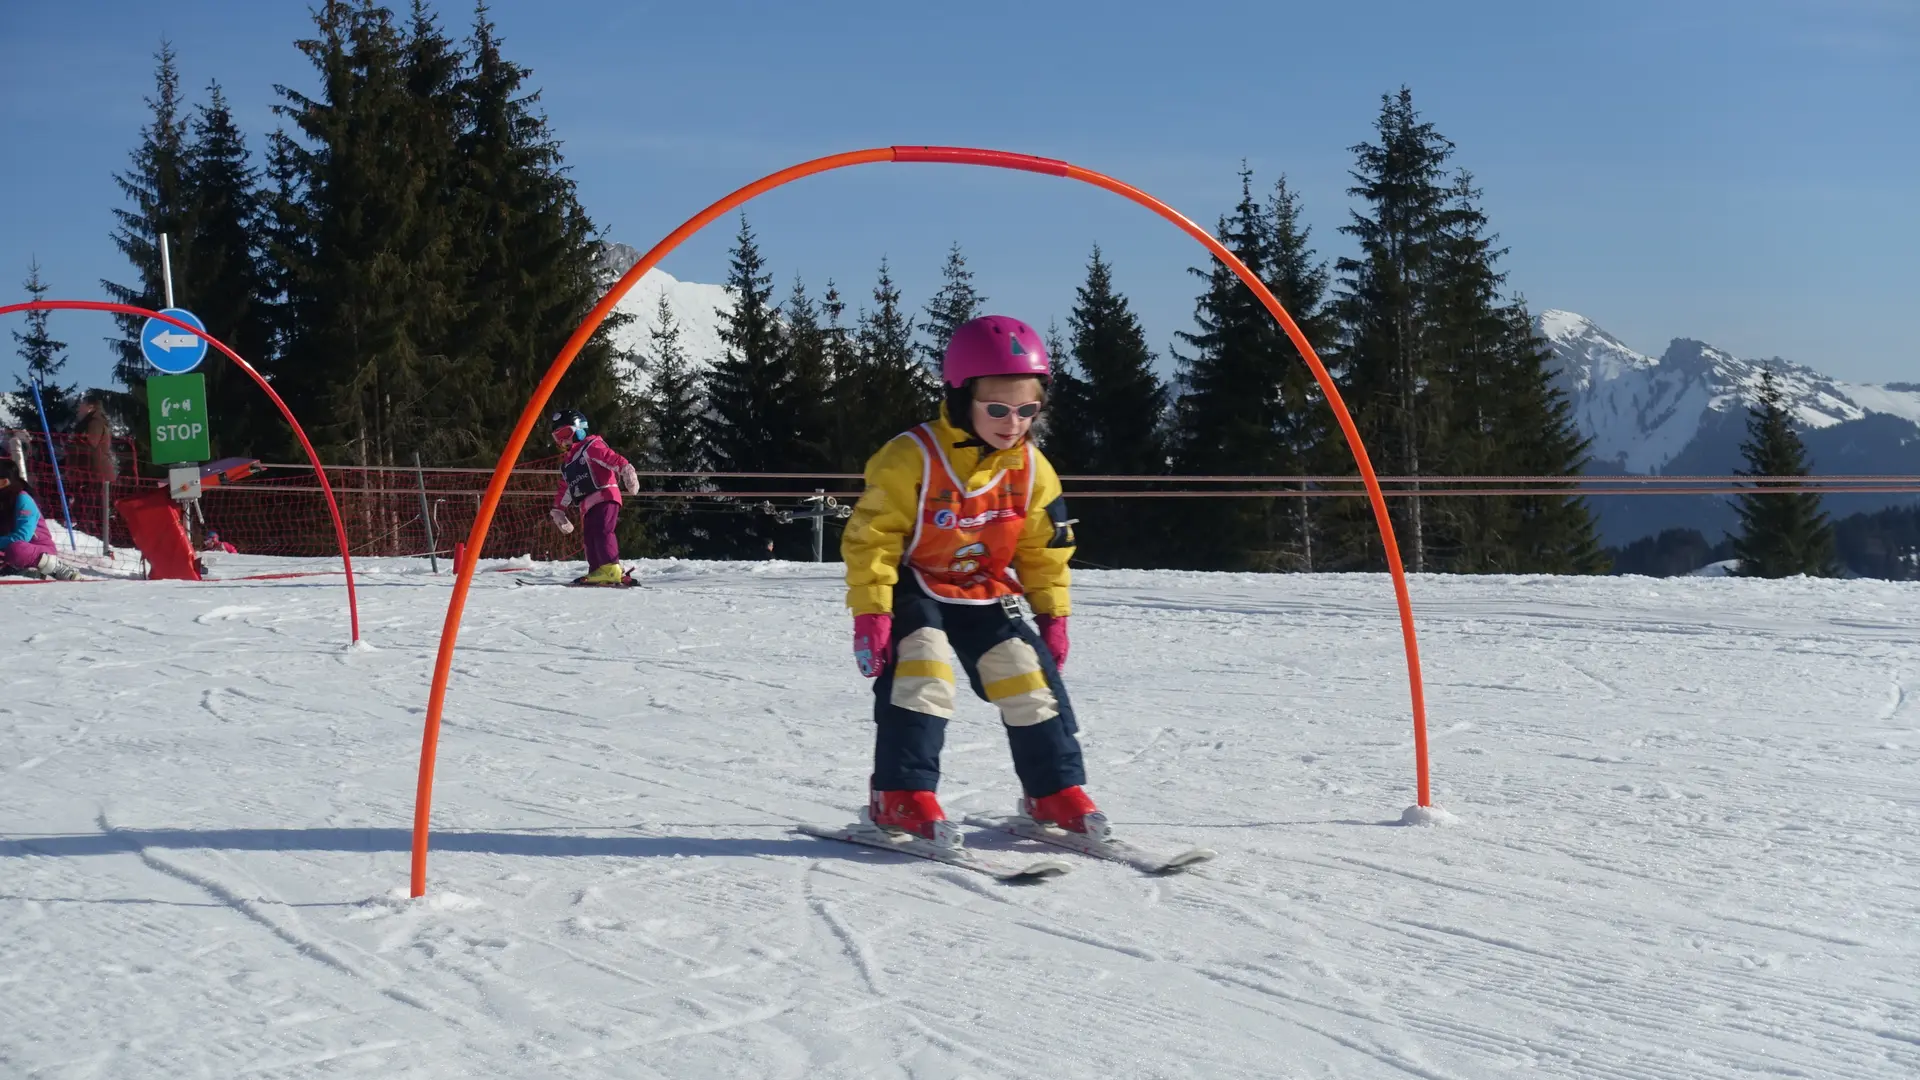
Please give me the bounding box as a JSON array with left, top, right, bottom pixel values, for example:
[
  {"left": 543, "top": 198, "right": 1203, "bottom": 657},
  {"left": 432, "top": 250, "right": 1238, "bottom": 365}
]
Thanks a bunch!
[{"left": 413, "top": 146, "right": 1430, "bottom": 896}]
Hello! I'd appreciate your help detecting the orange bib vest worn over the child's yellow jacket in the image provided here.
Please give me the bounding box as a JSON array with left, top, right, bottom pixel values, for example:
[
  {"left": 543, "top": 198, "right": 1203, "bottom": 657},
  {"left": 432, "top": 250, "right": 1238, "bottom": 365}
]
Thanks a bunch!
[{"left": 906, "top": 425, "right": 1033, "bottom": 603}]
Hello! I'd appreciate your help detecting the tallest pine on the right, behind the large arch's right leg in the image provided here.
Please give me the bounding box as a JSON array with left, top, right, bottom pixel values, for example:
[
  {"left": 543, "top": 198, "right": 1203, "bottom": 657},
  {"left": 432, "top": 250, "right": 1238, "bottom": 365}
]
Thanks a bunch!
[{"left": 1334, "top": 86, "right": 1453, "bottom": 571}]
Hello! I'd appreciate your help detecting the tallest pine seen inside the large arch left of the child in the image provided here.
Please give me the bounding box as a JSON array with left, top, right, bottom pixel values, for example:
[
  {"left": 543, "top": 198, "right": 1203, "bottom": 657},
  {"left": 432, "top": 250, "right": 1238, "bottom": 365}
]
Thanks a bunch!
[{"left": 705, "top": 213, "right": 795, "bottom": 557}]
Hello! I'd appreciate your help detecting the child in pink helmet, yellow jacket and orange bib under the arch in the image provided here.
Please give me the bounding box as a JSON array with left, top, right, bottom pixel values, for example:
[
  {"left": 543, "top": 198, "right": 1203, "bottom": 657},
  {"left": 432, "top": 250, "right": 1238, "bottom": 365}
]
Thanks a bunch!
[{"left": 841, "top": 315, "right": 1108, "bottom": 846}]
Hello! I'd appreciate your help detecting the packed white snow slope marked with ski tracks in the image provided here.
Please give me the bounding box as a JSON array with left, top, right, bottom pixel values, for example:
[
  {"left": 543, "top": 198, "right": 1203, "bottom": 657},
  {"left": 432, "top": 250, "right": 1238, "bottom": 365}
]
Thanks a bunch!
[{"left": 0, "top": 559, "right": 1920, "bottom": 1080}]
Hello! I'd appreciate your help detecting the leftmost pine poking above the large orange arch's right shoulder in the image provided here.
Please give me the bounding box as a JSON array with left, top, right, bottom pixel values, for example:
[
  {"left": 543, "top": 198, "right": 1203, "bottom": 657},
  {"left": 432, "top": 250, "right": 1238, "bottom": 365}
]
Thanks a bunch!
[{"left": 1173, "top": 167, "right": 1300, "bottom": 569}]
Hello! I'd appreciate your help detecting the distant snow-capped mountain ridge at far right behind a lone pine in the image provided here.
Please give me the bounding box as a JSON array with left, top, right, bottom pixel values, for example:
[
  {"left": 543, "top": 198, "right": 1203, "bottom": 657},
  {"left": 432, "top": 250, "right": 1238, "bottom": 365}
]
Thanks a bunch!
[{"left": 1534, "top": 309, "right": 1920, "bottom": 544}]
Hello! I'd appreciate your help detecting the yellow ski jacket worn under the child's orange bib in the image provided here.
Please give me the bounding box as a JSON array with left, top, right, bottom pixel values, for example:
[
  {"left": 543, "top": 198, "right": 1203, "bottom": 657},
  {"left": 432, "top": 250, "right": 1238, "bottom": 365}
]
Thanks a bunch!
[{"left": 841, "top": 405, "right": 1073, "bottom": 617}]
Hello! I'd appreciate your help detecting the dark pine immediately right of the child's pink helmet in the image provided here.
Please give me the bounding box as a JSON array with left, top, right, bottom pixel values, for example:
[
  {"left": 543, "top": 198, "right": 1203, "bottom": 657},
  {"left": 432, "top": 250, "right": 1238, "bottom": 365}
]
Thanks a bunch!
[{"left": 1046, "top": 246, "right": 1167, "bottom": 567}]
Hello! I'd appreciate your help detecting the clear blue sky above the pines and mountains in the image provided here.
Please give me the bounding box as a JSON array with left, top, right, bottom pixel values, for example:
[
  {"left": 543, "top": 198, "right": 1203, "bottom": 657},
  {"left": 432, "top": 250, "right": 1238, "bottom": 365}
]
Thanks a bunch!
[{"left": 0, "top": 0, "right": 1920, "bottom": 382}]
